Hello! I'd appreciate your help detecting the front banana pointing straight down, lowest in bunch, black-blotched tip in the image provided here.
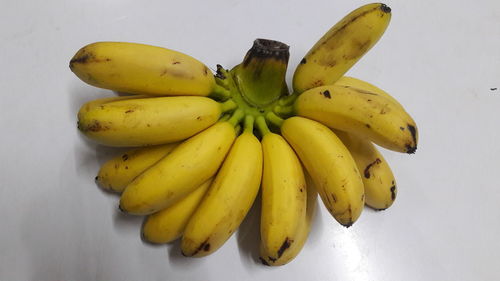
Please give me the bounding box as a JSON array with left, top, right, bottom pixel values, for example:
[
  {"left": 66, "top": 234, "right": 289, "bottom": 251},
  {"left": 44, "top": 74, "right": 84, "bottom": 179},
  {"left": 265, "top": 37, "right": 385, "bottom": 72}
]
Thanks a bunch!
[{"left": 258, "top": 116, "right": 307, "bottom": 264}]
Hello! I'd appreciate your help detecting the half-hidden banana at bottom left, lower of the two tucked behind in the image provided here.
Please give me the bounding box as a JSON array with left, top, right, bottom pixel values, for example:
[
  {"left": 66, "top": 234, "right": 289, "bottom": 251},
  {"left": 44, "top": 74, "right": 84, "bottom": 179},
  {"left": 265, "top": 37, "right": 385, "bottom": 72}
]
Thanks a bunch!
[{"left": 142, "top": 179, "right": 212, "bottom": 244}]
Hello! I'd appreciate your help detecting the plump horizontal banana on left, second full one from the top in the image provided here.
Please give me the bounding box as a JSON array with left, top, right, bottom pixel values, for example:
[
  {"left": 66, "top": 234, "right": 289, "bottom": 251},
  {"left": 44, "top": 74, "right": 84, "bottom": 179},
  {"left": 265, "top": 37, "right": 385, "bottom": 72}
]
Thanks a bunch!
[{"left": 78, "top": 97, "right": 234, "bottom": 147}]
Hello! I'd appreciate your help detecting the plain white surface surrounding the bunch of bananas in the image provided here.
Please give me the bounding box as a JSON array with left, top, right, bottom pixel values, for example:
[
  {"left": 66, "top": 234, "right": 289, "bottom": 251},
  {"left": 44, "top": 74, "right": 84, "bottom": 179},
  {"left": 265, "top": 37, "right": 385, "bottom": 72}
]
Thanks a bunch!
[{"left": 0, "top": 0, "right": 500, "bottom": 281}]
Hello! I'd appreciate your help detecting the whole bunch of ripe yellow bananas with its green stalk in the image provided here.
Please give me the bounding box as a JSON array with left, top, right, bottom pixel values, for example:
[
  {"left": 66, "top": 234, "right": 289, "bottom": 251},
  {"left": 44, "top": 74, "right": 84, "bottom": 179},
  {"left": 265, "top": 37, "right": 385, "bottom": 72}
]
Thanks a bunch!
[{"left": 70, "top": 3, "right": 417, "bottom": 265}]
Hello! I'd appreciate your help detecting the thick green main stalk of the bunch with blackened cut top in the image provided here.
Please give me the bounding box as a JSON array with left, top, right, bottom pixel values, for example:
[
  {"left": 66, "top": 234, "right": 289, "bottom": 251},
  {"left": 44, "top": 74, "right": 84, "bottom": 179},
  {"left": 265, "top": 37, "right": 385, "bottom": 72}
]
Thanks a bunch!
[{"left": 231, "top": 39, "right": 290, "bottom": 107}]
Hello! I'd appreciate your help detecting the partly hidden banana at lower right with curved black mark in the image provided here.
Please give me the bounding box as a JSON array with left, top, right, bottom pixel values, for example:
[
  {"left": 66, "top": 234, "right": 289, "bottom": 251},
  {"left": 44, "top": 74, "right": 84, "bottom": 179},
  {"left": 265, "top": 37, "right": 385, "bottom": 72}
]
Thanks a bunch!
[{"left": 335, "top": 131, "right": 397, "bottom": 210}]
